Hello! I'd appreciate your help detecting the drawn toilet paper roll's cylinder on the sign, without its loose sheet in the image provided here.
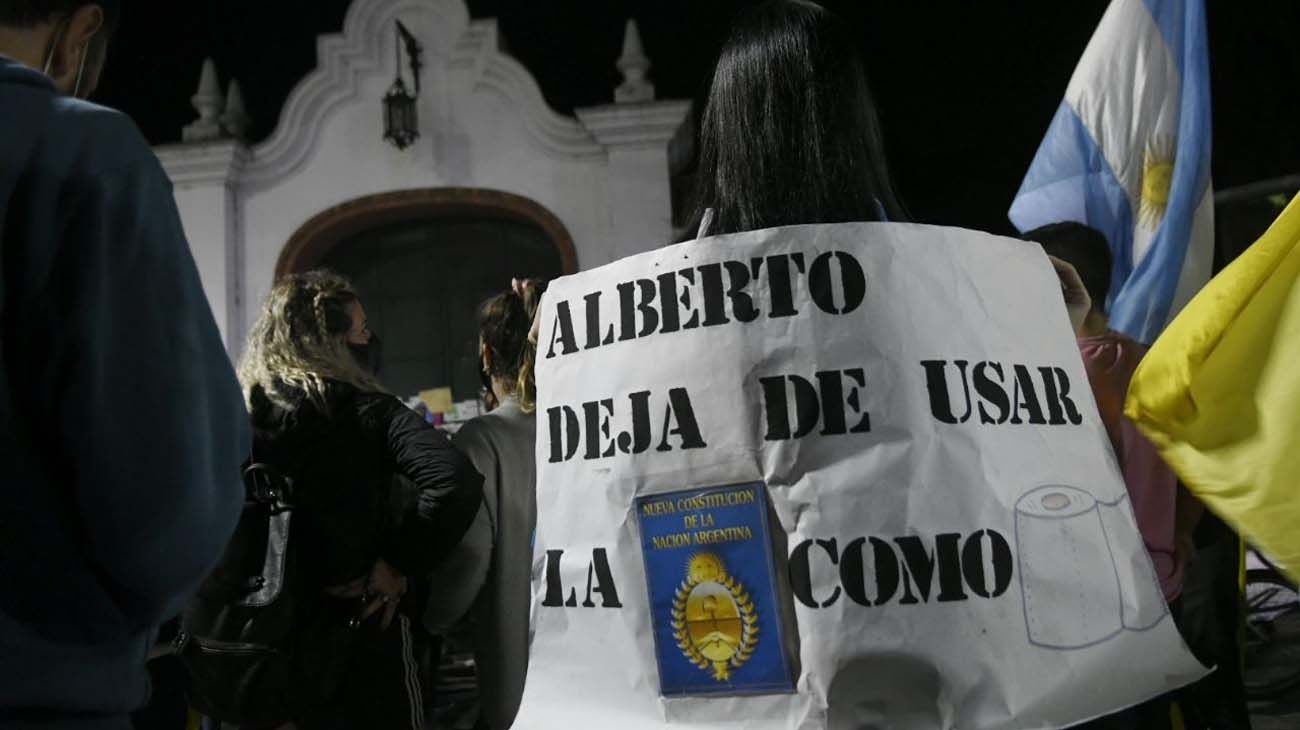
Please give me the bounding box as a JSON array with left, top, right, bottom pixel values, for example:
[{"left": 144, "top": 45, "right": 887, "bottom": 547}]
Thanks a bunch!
[{"left": 1015, "top": 485, "right": 1123, "bottom": 649}]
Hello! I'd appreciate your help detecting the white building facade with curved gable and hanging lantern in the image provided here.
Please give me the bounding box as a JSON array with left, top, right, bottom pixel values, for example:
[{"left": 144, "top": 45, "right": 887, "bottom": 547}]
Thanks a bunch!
[{"left": 157, "top": 0, "right": 692, "bottom": 355}]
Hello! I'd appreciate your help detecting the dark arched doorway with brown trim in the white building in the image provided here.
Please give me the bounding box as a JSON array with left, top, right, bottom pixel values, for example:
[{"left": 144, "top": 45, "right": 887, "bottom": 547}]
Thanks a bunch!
[{"left": 276, "top": 188, "right": 577, "bottom": 401}]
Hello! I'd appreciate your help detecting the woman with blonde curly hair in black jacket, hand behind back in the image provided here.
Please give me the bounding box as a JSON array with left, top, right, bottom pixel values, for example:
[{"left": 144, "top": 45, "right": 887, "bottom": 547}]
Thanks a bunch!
[{"left": 239, "top": 271, "right": 482, "bottom": 730}]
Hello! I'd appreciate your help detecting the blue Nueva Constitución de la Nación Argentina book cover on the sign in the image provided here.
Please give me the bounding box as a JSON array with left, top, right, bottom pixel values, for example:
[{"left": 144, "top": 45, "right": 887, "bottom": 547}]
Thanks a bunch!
[{"left": 636, "top": 482, "right": 794, "bottom": 696}]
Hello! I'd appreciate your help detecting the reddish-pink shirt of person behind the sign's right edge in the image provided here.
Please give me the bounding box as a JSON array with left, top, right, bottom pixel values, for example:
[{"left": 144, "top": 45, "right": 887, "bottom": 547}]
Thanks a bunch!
[{"left": 1079, "top": 331, "right": 1183, "bottom": 600}]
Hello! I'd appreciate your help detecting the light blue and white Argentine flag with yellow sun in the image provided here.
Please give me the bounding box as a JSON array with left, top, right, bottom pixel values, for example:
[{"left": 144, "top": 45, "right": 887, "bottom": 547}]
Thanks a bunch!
[{"left": 1010, "top": 0, "right": 1214, "bottom": 343}]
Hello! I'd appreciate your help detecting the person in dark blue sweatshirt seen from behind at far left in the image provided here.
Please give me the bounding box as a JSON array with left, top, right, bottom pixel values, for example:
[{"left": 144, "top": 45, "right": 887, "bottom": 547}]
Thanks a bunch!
[{"left": 0, "top": 0, "right": 250, "bottom": 729}]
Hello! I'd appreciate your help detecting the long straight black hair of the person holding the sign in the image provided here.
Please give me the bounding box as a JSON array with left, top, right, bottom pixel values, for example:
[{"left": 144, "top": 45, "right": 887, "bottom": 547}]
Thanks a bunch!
[{"left": 690, "top": 0, "right": 906, "bottom": 235}]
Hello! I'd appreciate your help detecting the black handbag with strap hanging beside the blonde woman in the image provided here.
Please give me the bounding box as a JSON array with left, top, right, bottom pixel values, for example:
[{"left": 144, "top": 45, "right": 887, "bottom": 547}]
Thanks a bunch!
[{"left": 177, "top": 462, "right": 356, "bottom": 724}]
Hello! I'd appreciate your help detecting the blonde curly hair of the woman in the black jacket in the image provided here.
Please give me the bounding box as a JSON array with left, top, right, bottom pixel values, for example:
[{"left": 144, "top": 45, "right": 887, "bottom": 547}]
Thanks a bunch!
[{"left": 239, "top": 270, "right": 385, "bottom": 410}]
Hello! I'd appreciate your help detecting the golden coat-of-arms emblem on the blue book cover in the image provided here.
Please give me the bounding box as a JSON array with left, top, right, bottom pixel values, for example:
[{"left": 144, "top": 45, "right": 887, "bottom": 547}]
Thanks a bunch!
[{"left": 672, "top": 552, "right": 758, "bottom": 682}]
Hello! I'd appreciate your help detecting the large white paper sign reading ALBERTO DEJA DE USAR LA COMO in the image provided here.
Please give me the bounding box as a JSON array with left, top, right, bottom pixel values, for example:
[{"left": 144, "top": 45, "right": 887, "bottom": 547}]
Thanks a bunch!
[{"left": 515, "top": 223, "right": 1204, "bottom": 730}]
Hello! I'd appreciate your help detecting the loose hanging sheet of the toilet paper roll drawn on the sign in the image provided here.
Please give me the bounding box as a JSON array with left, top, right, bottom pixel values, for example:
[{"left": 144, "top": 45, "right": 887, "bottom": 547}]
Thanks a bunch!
[{"left": 1099, "top": 494, "right": 1169, "bottom": 631}]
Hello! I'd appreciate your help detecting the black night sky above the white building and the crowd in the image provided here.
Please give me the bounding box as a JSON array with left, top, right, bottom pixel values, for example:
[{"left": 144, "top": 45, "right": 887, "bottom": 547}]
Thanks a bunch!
[{"left": 98, "top": 0, "right": 1300, "bottom": 233}]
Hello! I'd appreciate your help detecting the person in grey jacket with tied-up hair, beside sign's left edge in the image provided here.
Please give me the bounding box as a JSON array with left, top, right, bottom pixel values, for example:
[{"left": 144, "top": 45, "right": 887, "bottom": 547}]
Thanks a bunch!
[{"left": 425, "top": 281, "right": 545, "bottom": 730}]
